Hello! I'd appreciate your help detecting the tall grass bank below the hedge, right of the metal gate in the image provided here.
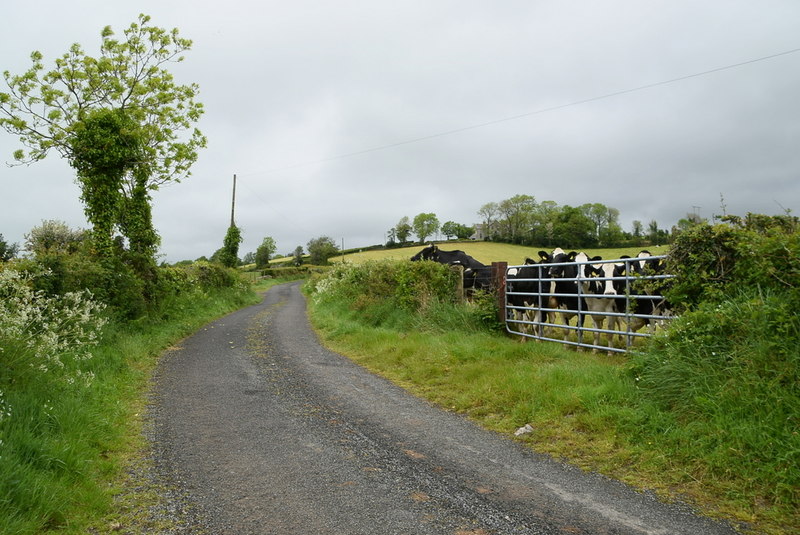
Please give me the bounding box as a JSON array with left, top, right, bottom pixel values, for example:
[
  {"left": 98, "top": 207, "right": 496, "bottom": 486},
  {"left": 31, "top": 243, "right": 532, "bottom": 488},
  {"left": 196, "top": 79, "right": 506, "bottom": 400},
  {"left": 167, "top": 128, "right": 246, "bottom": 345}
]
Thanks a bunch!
[{"left": 628, "top": 290, "right": 800, "bottom": 508}]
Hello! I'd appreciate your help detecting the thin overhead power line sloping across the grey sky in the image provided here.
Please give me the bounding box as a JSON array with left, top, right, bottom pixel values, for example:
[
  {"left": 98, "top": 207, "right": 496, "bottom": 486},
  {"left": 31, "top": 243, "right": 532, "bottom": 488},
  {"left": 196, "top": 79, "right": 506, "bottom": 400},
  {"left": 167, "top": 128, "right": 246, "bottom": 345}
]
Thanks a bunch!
[{"left": 241, "top": 48, "right": 800, "bottom": 175}]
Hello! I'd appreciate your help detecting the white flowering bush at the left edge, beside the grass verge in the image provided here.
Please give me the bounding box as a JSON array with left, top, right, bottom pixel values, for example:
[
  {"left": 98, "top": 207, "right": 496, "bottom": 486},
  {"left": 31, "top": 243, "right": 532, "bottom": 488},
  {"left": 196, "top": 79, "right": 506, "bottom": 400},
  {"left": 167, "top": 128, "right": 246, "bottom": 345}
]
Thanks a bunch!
[{"left": 0, "top": 269, "right": 106, "bottom": 392}]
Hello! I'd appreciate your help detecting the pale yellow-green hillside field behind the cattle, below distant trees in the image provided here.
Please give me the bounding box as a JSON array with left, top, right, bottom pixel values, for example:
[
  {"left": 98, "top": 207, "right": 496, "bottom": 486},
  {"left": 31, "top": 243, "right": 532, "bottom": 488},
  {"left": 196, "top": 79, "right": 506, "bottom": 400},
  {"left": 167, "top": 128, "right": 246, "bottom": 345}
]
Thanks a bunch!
[{"left": 331, "top": 241, "right": 667, "bottom": 265}]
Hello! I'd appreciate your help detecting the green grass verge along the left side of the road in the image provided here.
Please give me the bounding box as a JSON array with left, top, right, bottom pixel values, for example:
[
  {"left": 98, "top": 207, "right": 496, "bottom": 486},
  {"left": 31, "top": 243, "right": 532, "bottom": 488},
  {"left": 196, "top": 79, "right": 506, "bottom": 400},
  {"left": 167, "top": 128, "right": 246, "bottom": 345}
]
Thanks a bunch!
[{"left": 0, "top": 281, "right": 304, "bottom": 535}]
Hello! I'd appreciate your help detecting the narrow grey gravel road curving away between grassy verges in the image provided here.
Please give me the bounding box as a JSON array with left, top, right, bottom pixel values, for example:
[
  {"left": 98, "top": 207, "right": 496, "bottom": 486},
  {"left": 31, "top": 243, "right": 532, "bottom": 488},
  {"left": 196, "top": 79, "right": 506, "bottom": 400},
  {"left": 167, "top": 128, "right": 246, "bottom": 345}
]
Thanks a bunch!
[{"left": 151, "top": 283, "right": 735, "bottom": 535}]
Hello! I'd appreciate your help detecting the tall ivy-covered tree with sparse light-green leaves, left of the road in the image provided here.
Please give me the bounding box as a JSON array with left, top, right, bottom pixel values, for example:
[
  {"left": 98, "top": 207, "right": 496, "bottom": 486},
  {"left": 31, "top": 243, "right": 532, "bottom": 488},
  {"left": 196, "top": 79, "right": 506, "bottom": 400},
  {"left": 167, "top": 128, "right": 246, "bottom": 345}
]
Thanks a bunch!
[{"left": 0, "top": 15, "right": 206, "bottom": 264}]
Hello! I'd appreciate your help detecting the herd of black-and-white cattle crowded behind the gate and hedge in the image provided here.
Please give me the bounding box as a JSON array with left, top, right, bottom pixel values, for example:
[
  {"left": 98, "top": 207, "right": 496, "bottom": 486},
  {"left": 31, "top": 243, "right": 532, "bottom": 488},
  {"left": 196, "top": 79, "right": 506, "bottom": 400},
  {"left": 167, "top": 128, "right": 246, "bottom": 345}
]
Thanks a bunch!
[{"left": 411, "top": 245, "right": 670, "bottom": 350}]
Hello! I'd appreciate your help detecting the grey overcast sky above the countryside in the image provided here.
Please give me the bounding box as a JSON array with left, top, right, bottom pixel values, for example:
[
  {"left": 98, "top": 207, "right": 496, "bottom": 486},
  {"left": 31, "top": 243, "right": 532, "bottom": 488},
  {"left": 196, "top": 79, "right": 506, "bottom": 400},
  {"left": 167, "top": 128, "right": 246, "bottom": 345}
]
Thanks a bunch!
[{"left": 0, "top": 0, "right": 800, "bottom": 262}]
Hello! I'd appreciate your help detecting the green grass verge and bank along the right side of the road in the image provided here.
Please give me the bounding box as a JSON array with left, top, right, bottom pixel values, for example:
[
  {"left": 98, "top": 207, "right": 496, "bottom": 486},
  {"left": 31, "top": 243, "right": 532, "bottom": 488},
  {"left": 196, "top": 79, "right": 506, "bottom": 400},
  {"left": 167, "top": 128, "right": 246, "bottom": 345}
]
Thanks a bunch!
[{"left": 309, "top": 262, "right": 800, "bottom": 535}]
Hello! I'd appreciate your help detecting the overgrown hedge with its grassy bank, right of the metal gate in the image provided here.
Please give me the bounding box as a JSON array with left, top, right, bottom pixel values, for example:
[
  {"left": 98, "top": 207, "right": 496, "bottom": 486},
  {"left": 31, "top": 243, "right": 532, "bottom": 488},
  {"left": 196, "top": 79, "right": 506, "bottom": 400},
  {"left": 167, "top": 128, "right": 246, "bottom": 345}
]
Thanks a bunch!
[{"left": 631, "top": 214, "right": 800, "bottom": 507}]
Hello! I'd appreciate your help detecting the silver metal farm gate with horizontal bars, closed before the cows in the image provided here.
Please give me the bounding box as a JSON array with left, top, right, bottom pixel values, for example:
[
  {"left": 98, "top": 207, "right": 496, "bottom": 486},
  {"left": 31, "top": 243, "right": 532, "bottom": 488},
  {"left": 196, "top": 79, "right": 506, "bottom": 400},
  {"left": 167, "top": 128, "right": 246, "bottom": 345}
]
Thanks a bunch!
[{"left": 506, "top": 256, "right": 673, "bottom": 353}]
